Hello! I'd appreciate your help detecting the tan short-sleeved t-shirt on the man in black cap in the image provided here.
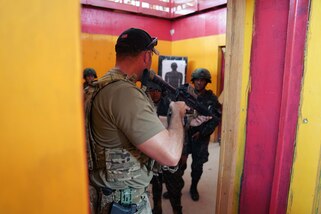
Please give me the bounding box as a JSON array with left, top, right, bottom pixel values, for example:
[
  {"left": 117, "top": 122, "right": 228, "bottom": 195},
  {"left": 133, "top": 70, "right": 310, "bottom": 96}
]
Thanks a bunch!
[{"left": 92, "top": 75, "right": 165, "bottom": 189}]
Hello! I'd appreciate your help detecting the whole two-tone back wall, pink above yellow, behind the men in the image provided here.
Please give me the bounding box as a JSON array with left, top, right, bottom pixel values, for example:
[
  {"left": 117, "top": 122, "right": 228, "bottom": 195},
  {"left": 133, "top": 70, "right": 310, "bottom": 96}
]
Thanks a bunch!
[{"left": 81, "top": 5, "right": 226, "bottom": 95}]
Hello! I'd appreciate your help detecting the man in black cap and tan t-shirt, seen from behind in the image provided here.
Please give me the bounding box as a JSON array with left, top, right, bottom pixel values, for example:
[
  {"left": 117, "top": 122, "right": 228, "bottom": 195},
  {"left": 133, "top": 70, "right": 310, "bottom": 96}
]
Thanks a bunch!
[{"left": 90, "top": 28, "right": 188, "bottom": 214}]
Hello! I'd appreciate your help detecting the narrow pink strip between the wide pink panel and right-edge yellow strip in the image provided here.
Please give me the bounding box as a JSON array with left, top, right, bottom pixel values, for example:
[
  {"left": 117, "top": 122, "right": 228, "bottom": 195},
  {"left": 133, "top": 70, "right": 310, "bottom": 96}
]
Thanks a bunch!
[{"left": 270, "top": 0, "right": 309, "bottom": 213}]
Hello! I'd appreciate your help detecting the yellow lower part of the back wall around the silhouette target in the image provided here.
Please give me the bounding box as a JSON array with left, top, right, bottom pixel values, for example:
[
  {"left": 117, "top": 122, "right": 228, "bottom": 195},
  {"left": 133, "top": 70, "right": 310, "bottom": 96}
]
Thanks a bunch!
[{"left": 81, "top": 33, "right": 225, "bottom": 93}]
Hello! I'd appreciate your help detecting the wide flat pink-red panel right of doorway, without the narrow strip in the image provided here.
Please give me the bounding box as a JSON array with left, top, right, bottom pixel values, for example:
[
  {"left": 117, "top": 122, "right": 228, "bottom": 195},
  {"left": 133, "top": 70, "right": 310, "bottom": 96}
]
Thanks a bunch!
[{"left": 240, "top": 0, "right": 289, "bottom": 214}]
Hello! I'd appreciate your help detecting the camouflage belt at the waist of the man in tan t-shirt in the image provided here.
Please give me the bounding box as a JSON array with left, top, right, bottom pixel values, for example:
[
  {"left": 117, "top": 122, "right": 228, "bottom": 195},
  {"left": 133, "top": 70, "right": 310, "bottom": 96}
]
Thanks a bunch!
[{"left": 101, "top": 187, "right": 147, "bottom": 205}]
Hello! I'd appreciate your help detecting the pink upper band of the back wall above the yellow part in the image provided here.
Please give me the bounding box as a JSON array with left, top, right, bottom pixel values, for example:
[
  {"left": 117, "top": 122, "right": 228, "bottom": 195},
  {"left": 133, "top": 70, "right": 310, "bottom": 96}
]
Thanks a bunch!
[{"left": 81, "top": 5, "right": 226, "bottom": 41}]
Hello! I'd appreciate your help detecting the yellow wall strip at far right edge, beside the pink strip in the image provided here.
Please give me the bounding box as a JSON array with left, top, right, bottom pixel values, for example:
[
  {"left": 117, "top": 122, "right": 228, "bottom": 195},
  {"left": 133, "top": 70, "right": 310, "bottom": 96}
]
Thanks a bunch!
[{"left": 287, "top": 1, "right": 321, "bottom": 214}]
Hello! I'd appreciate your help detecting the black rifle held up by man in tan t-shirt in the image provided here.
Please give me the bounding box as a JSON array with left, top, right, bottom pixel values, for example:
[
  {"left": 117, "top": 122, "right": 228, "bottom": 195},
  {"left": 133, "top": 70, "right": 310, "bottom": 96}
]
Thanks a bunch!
[{"left": 142, "top": 69, "right": 222, "bottom": 121}]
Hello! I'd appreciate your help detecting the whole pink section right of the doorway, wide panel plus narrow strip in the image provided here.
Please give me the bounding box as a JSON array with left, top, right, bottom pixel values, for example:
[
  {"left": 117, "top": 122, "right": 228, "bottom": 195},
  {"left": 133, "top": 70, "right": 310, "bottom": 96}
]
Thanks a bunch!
[{"left": 239, "top": 0, "right": 309, "bottom": 214}]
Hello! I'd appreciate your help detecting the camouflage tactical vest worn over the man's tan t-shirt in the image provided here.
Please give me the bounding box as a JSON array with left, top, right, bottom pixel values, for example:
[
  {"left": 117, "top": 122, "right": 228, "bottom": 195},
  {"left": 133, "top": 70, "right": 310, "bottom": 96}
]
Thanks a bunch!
[{"left": 84, "top": 69, "right": 154, "bottom": 182}]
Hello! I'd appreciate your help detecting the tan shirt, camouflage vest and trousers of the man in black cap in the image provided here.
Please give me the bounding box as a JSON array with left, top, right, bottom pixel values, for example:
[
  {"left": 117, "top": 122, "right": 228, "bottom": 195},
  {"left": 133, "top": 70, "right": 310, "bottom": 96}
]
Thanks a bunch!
[{"left": 86, "top": 69, "right": 165, "bottom": 213}]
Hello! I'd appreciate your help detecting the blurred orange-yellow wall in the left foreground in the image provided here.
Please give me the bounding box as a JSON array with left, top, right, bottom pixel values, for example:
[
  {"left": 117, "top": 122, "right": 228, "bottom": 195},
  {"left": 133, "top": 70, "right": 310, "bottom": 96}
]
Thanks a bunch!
[{"left": 0, "top": 0, "right": 88, "bottom": 214}]
